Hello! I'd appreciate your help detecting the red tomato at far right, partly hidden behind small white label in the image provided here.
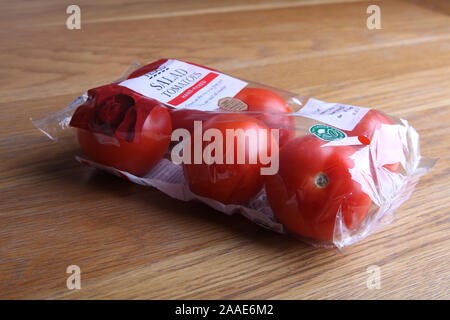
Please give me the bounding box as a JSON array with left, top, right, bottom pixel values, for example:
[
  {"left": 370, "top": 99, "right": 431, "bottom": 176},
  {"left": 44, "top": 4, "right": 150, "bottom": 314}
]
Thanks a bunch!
[{"left": 347, "top": 109, "right": 402, "bottom": 172}]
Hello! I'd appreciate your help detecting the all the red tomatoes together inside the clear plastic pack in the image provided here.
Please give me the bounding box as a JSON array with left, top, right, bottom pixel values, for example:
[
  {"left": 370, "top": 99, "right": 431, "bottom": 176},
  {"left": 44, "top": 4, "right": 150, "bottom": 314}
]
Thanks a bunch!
[{"left": 71, "top": 60, "right": 399, "bottom": 240}]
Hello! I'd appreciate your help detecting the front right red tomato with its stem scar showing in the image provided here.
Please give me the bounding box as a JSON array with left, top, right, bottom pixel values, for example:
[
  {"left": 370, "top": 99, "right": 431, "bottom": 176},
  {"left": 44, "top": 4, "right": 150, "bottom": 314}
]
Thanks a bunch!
[{"left": 265, "top": 136, "right": 371, "bottom": 240}]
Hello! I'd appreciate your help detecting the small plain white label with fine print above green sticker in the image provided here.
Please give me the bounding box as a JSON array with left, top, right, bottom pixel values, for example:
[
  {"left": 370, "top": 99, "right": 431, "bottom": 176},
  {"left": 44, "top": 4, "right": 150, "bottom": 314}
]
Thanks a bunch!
[{"left": 296, "top": 98, "right": 370, "bottom": 131}]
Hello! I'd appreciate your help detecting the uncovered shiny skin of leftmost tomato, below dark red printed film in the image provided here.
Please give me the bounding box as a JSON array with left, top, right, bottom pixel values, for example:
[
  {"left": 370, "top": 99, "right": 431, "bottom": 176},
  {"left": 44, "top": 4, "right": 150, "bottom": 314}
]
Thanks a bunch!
[{"left": 77, "top": 106, "right": 172, "bottom": 176}]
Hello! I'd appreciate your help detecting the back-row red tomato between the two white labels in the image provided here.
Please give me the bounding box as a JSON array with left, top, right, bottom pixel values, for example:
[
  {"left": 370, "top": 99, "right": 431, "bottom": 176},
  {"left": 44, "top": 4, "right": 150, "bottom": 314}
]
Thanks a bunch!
[{"left": 235, "top": 88, "right": 295, "bottom": 147}]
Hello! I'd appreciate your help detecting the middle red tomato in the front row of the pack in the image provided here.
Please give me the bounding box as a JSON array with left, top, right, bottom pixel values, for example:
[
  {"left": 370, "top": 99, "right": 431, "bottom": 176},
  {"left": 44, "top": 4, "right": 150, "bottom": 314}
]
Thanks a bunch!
[{"left": 183, "top": 113, "right": 271, "bottom": 204}]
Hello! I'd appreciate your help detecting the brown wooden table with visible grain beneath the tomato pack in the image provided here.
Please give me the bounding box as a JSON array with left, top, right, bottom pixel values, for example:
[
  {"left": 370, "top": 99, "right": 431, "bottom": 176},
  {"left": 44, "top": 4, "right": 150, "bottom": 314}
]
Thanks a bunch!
[{"left": 0, "top": 0, "right": 450, "bottom": 299}]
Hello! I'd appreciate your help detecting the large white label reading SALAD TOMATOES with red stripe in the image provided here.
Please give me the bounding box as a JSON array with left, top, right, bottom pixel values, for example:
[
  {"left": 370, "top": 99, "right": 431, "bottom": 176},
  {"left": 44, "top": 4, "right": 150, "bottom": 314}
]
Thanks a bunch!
[{"left": 119, "top": 60, "right": 248, "bottom": 111}]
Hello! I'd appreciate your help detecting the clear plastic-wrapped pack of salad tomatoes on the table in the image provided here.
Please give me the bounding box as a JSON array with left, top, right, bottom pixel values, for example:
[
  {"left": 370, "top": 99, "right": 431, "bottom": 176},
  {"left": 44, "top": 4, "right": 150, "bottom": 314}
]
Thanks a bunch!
[{"left": 34, "top": 59, "right": 434, "bottom": 248}]
